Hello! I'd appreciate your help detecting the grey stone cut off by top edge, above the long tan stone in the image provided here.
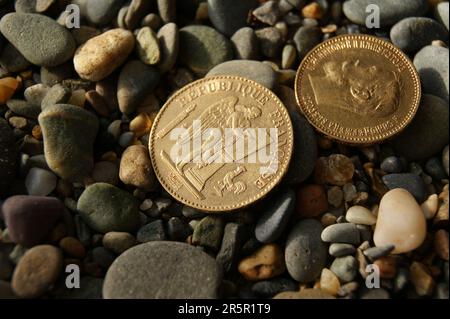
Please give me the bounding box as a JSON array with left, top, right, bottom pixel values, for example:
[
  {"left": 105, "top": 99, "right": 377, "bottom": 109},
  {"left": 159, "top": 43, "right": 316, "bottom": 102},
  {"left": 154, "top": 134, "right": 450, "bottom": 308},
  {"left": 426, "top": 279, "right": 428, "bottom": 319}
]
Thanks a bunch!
[{"left": 86, "top": 0, "right": 124, "bottom": 25}]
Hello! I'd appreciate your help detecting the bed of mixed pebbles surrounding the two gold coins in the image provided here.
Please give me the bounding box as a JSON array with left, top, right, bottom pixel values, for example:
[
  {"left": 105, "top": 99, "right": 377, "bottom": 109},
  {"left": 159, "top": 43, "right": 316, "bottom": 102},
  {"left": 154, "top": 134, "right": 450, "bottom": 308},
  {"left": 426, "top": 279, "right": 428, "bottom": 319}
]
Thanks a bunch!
[{"left": 0, "top": 0, "right": 449, "bottom": 299}]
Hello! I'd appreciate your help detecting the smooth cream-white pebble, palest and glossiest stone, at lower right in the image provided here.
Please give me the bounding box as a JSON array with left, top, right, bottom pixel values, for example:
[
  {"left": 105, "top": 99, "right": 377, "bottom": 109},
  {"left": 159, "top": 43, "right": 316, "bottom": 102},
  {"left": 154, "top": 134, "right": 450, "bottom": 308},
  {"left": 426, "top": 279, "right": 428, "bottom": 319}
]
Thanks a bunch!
[{"left": 373, "top": 188, "right": 427, "bottom": 254}]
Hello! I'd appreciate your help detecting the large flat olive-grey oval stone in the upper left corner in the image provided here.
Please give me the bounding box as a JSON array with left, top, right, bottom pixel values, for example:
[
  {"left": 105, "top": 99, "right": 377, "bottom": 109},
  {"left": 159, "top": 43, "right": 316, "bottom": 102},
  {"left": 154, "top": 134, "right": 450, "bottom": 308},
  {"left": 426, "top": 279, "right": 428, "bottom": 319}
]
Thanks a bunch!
[{"left": 0, "top": 13, "right": 75, "bottom": 66}]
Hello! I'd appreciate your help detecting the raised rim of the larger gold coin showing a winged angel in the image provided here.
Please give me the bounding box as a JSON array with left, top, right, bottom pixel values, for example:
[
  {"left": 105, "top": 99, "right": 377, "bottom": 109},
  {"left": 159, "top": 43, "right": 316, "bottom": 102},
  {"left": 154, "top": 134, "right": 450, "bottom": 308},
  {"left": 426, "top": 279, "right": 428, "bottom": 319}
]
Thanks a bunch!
[{"left": 148, "top": 75, "right": 294, "bottom": 213}]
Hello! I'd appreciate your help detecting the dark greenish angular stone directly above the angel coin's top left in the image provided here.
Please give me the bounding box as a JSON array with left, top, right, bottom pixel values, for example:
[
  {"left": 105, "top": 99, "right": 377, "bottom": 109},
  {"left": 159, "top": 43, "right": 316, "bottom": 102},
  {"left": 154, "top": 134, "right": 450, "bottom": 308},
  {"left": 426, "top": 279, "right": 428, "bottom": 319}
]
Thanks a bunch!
[{"left": 178, "top": 25, "right": 233, "bottom": 76}]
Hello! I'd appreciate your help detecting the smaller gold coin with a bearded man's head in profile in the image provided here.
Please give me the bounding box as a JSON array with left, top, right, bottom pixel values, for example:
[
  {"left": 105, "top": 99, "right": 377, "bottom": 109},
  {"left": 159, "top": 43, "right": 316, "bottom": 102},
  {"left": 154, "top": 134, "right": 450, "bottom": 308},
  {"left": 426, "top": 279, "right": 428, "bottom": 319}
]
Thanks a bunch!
[{"left": 295, "top": 35, "right": 421, "bottom": 144}]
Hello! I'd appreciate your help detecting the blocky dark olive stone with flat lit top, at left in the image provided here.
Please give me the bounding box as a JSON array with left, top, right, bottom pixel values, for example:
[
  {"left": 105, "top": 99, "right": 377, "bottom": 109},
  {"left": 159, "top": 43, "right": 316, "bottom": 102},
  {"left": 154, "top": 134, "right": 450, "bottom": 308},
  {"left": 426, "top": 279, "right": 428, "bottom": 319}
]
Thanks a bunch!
[{"left": 39, "top": 104, "right": 99, "bottom": 181}]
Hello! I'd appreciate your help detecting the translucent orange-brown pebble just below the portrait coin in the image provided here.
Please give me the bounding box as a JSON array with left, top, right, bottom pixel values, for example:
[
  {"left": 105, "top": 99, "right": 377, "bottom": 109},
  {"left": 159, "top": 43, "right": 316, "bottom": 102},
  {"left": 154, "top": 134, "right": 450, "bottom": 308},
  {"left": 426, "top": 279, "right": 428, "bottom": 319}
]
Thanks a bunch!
[{"left": 314, "top": 154, "right": 355, "bottom": 186}]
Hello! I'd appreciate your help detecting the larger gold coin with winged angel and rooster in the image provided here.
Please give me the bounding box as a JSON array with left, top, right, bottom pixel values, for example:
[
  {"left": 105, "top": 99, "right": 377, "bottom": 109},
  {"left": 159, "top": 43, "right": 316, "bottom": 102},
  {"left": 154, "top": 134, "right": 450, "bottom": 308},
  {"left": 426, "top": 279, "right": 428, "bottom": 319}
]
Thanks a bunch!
[{"left": 149, "top": 76, "right": 293, "bottom": 212}]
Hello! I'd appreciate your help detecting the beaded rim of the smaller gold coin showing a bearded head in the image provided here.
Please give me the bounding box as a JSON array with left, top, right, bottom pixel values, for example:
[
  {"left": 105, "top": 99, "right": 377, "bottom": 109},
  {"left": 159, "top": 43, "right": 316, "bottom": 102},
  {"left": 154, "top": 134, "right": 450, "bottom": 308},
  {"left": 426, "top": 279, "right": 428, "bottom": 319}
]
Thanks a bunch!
[{"left": 294, "top": 34, "right": 422, "bottom": 144}]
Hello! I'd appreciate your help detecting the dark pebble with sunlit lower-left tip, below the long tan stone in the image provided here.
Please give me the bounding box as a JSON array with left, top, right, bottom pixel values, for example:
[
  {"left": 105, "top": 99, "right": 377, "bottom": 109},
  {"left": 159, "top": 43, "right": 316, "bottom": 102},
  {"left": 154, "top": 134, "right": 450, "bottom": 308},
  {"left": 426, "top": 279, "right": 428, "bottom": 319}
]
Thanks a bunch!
[{"left": 117, "top": 60, "right": 160, "bottom": 114}]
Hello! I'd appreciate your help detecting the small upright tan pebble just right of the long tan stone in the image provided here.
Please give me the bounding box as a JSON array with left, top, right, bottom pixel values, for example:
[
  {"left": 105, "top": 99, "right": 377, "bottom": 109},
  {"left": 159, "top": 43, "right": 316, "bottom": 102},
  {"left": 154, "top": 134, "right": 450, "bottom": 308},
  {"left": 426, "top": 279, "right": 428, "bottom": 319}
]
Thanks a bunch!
[{"left": 136, "top": 27, "right": 161, "bottom": 65}]
